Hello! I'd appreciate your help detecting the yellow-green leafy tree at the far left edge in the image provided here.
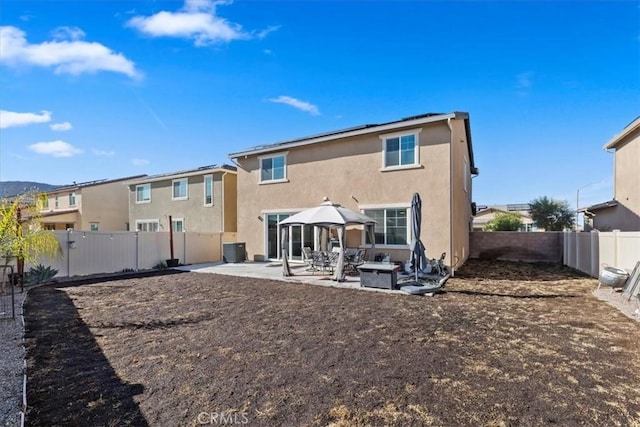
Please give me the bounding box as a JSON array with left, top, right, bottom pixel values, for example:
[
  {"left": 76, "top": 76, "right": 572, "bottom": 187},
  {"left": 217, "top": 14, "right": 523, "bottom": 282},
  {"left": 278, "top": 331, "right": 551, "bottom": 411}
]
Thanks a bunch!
[{"left": 0, "top": 195, "right": 61, "bottom": 280}]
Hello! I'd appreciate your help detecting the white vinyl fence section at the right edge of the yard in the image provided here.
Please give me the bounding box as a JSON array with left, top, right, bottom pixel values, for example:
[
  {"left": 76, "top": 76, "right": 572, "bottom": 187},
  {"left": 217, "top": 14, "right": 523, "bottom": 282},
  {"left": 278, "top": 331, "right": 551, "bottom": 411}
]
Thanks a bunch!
[{"left": 564, "top": 231, "right": 640, "bottom": 277}]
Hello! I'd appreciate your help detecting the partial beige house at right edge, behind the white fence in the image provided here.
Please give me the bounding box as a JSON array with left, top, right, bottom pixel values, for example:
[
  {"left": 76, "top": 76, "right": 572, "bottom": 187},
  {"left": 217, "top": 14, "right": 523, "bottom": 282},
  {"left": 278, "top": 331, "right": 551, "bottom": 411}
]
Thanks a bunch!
[{"left": 579, "top": 117, "right": 640, "bottom": 231}]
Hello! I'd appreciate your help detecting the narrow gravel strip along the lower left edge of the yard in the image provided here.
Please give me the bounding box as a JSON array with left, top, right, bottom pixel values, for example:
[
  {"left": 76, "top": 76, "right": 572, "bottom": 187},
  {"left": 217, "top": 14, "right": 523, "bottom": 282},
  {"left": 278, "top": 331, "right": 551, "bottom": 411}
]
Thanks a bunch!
[{"left": 0, "top": 291, "right": 27, "bottom": 427}]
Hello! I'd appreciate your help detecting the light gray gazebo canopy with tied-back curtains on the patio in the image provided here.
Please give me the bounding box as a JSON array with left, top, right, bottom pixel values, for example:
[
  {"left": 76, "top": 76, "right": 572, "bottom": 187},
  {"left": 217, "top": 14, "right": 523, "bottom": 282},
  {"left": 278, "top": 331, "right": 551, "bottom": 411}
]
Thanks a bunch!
[{"left": 279, "top": 198, "right": 376, "bottom": 281}]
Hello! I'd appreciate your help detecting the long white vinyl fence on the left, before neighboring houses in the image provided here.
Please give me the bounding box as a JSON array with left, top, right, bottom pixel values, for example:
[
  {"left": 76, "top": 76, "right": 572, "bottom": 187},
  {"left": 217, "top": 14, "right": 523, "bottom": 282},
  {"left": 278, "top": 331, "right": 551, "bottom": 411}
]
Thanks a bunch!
[{"left": 30, "top": 230, "right": 222, "bottom": 276}]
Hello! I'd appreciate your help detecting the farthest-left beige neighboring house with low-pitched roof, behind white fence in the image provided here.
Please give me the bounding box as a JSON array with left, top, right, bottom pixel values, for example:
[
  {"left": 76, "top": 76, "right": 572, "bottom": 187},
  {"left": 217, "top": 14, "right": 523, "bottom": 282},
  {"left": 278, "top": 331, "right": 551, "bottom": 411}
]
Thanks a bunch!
[{"left": 41, "top": 175, "right": 144, "bottom": 231}]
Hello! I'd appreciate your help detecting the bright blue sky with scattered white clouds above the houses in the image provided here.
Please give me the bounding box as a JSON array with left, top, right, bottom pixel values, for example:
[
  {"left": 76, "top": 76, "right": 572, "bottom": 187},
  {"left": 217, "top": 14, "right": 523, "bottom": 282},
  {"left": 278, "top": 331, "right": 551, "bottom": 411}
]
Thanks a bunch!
[{"left": 0, "top": 0, "right": 640, "bottom": 211}]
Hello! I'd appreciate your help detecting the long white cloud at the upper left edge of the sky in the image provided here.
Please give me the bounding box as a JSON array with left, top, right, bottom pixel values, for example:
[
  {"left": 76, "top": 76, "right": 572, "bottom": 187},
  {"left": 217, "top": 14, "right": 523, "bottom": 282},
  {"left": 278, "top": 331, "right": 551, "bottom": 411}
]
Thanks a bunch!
[{"left": 0, "top": 26, "right": 141, "bottom": 78}]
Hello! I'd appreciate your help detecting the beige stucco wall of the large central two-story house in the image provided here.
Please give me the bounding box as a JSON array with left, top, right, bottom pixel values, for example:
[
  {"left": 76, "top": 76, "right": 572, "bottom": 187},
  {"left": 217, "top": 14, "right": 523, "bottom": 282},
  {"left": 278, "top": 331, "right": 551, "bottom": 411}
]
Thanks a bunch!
[{"left": 236, "top": 120, "right": 470, "bottom": 263}]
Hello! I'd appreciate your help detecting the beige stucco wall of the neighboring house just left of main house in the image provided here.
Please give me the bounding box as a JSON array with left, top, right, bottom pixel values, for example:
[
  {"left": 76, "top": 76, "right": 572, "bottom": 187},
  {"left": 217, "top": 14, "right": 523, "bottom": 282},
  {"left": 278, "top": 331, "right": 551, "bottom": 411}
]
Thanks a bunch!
[{"left": 129, "top": 171, "right": 231, "bottom": 233}]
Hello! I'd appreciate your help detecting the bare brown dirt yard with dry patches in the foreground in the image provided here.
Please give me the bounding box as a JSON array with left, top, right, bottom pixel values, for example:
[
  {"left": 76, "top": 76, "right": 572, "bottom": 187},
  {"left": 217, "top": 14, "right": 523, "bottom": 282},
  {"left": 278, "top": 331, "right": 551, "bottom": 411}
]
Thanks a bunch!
[{"left": 25, "top": 261, "right": 640, "bottom": 426}]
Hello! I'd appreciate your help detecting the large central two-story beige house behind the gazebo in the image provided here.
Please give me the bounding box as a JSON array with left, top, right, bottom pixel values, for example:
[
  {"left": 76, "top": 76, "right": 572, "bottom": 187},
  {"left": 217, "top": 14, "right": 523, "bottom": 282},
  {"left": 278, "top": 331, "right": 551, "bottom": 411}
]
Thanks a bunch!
[{"left": 229, "top": 112, "right": 478, "bottom": 265}]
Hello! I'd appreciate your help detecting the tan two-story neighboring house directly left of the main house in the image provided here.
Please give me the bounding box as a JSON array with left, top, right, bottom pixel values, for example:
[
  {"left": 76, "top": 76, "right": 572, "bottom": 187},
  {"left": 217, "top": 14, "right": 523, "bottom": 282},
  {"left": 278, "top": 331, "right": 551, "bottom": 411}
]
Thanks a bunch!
[{"left": 127, "top": 165, "right": 237, "bottom": 237}]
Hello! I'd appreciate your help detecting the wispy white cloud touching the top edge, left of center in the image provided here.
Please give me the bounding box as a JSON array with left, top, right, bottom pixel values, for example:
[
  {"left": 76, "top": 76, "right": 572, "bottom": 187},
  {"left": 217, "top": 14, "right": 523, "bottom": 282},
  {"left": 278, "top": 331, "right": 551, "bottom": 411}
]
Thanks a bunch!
[{"left": 127, "top": 0, "right": 279, "bottom": 46}]
